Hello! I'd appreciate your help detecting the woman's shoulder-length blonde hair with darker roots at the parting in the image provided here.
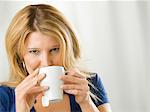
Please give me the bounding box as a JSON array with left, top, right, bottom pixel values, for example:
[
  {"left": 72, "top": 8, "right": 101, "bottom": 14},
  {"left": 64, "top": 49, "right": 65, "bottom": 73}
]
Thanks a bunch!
[{"left": 1, "top": 4, "right": 80, "bottom": 86}]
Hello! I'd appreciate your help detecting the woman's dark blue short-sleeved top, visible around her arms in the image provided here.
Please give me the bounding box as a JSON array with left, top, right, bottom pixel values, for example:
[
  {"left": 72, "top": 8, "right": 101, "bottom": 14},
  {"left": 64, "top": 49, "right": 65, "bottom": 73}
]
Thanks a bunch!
[{"left": 0, "top": 74, "right": 108, "bottom": 112}]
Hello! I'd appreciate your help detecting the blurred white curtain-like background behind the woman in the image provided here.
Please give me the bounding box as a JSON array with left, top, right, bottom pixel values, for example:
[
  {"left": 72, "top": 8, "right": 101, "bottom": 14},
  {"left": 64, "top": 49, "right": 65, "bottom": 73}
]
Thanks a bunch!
[{"left": 0, "top": 0, "right": 150, "bottom": 112}]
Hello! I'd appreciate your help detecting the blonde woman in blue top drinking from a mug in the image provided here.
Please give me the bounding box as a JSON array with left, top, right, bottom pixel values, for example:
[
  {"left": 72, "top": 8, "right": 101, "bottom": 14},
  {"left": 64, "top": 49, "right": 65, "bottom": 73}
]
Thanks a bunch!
[{"left": 0, "top": 4, "right": 111, "bottom": 112}]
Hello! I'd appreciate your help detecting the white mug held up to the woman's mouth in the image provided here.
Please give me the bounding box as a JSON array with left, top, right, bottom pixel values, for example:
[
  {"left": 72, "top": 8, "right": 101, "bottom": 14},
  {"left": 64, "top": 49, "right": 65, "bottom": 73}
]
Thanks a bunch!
[{"left": 39, "top": 66, "right": 64, "bottom": 106}]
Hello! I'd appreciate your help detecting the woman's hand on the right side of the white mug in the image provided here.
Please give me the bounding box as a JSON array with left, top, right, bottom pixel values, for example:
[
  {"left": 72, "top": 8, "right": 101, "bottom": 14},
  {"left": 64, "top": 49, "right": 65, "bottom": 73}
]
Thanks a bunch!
[{"left": 60, "top": 69, "right": 90, "bottom": 104}]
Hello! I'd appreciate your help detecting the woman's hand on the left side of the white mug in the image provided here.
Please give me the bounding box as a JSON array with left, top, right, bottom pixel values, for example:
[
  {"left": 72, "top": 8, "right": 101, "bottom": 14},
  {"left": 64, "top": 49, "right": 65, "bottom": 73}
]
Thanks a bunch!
[{"left": 15, "top": 69, "right": 48, "bottom": 112}]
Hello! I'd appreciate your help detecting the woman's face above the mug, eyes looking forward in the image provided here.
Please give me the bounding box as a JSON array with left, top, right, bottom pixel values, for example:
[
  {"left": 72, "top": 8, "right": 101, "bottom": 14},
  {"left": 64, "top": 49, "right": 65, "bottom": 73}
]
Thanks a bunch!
[{"left": 23, "top": 32, "right": 62, "bottom": 74}]
